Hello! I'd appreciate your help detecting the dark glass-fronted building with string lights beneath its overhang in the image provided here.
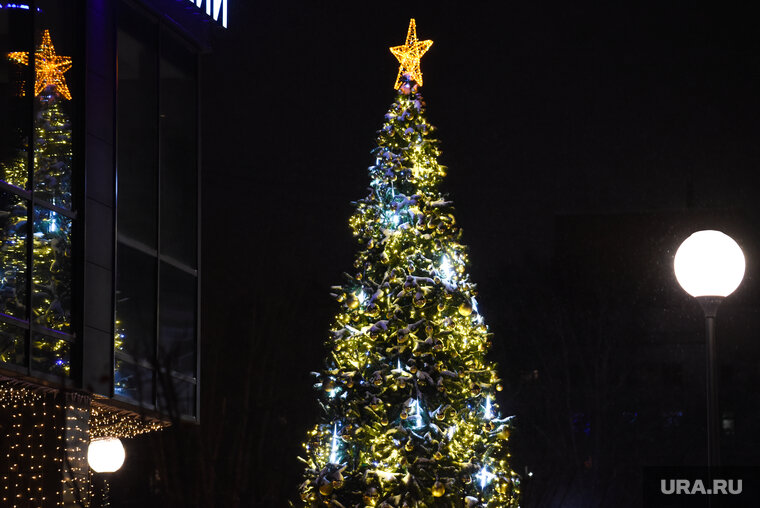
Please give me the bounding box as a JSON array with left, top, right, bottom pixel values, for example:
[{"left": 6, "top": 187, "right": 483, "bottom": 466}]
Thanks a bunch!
[{"left": 0, "top": 0, "right": 227, "bottom": 506}]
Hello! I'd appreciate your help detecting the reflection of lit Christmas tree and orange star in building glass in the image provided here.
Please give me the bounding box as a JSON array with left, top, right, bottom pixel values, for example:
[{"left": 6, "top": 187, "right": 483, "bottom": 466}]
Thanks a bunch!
[{"left": 0, "top": 30, "right": 72, "bottom": 374}]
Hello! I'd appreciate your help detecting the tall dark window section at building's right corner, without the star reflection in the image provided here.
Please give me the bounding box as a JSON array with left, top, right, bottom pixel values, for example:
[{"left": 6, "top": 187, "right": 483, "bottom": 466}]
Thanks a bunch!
[{"left": 115, "top": 3, "right": 198, "bottom": 415}]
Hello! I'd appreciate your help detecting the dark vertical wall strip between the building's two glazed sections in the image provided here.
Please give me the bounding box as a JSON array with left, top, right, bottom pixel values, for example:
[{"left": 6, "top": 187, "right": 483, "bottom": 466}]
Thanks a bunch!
[{"left": 80, "top": 0, "right": 116, "bottom": 397}]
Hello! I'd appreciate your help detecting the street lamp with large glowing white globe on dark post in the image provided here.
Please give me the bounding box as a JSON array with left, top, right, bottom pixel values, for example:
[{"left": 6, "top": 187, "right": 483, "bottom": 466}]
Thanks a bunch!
[{"left": 673, "top": 230, "right": 745, "bottom": 466}]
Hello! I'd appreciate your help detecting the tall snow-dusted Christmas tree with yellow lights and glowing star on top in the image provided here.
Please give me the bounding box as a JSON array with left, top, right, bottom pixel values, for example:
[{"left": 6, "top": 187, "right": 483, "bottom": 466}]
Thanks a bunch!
[{"left": 300, "top": 20, "right": 519, "bottom": 508}]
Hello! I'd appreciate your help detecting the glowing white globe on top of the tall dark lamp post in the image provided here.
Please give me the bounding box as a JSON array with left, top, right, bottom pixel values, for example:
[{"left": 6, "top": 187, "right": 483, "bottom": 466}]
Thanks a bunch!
[{"left": 673, "top": 230, "right": 745, "bottom": 296}]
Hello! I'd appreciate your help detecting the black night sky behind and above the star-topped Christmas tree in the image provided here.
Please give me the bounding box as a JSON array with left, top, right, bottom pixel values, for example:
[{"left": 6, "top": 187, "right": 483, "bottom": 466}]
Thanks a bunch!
[{"left": 193, "top": 0, "right": 760, "bottom": 505}]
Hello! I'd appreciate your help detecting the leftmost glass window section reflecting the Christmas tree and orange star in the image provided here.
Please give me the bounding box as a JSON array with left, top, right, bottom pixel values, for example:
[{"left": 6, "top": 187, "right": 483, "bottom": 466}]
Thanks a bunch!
[{"left": 0, "top": 0, "right": 83, "bottom": 376}]
